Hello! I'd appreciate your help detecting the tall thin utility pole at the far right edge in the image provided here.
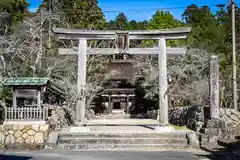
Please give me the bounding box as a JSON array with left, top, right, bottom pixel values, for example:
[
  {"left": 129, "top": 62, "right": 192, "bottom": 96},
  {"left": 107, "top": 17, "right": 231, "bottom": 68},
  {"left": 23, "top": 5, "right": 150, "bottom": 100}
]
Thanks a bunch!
[{"left": 232, "top": 0, "right": 238, "bottom": 111}]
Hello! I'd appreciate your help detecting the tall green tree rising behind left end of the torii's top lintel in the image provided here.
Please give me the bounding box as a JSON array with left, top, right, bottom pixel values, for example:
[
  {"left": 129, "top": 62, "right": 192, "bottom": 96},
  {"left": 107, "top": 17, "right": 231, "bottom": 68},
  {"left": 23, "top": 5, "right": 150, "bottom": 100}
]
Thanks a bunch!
[{"left": 40, "top": 0, "right": 106, "bottom": 29}]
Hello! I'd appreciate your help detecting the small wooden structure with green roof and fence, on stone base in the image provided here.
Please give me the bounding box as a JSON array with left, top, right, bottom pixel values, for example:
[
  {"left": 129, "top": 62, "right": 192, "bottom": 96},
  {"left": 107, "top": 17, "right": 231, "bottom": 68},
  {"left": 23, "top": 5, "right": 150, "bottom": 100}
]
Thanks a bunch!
[{"left": 2, "top": 77, "right": 65, "bottom": 121}]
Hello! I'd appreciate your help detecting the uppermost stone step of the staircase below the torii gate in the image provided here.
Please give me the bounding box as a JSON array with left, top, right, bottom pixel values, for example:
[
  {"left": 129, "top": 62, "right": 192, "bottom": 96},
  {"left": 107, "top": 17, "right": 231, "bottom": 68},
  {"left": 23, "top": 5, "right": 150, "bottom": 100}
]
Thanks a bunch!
[{"left": 59, "top": 131, "right": 186, "bottom": 139}]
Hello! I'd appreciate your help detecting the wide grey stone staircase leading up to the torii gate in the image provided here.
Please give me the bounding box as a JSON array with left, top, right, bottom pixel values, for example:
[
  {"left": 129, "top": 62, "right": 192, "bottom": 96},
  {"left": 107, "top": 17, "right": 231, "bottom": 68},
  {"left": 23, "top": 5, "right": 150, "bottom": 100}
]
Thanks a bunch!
[{"left": 51, "top": 132, "right": 189, "bottom": 150}]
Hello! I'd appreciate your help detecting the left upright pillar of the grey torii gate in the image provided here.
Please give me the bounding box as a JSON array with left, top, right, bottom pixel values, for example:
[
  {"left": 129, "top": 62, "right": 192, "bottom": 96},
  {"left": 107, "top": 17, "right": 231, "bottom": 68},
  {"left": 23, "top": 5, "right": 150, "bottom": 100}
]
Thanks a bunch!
[{"left": 76, "top": 39, "right": 87, "bottom": 125}]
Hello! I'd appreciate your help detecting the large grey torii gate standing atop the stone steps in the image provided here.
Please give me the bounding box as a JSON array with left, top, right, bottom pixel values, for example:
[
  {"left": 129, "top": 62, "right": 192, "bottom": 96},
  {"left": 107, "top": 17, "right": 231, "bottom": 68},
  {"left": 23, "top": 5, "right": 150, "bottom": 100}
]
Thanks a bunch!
[{"left": 53, "top": 27, "right": 191, "bottom": 131}]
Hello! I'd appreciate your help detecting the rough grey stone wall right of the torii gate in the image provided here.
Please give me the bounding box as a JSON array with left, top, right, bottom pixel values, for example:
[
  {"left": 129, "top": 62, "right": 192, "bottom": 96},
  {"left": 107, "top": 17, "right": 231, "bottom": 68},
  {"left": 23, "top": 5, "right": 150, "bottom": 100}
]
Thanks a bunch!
[{"left": 148, "top": 106, "right": 240, "bottom": 142}]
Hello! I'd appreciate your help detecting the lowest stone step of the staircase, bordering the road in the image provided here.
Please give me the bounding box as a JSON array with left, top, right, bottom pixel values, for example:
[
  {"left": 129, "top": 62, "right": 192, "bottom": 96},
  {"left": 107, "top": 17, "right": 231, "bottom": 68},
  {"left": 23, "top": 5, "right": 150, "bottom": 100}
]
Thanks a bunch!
[{"left": 52, "top": 143, "right": 189, "bottom": 150}]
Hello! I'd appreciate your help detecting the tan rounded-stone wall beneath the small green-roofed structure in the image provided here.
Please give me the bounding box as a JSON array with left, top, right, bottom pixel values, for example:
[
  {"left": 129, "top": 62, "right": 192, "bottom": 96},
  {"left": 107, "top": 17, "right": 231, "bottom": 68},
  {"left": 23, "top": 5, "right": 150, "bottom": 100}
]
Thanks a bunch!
[{"left": 0, "top": 124, "right": 49, "bottom": 148}]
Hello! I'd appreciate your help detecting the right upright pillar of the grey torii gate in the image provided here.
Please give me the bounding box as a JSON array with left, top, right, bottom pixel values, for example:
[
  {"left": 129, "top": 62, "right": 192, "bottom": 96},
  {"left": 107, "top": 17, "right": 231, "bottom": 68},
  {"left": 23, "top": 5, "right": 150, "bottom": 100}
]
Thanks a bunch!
[{"left": 158, "top": 38, "right": 168, "bottom": 126}]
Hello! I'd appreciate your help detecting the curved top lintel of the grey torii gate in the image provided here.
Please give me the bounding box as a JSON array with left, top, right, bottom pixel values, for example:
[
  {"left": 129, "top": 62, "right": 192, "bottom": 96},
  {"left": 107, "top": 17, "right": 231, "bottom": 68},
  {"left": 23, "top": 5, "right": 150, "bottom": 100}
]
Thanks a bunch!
[{"left": 53, "top": 27, "right": 191, "bottom": 40}]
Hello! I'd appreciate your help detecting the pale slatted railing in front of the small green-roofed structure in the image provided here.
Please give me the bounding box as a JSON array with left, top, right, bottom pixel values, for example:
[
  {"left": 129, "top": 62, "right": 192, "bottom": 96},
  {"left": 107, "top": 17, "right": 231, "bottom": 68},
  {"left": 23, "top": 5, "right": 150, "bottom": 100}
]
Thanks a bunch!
[{"left": 5, "top": 107, "right": 48, "bottom": 121}]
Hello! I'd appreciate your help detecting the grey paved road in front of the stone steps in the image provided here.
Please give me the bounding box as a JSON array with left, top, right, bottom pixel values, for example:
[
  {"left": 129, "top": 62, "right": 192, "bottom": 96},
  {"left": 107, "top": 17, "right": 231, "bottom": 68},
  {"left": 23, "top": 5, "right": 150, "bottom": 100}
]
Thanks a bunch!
[{"left": 0, "top": 151, "right": 212, "bottom": 160}]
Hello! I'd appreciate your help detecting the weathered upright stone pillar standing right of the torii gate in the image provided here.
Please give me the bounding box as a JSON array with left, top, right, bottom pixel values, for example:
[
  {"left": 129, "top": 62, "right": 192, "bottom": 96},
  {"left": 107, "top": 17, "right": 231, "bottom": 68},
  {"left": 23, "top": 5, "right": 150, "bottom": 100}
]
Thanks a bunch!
[{"left": 210, "top": 55, "right": 220, "bottom": 119}]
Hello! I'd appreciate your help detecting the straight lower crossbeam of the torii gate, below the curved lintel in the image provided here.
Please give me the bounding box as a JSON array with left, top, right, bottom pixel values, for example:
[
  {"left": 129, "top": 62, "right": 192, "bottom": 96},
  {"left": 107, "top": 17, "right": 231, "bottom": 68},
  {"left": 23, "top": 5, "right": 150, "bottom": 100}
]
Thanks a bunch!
[{"left": 58, "top": 48, "right": 186, "bottom": 55}]
